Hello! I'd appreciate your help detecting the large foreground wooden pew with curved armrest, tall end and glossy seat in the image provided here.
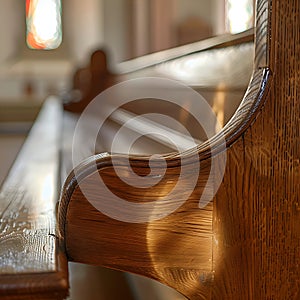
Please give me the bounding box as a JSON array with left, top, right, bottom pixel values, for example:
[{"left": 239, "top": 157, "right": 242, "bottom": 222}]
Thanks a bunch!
[{"left": 0, "top": 0, "right": 300, "bottom": 299}]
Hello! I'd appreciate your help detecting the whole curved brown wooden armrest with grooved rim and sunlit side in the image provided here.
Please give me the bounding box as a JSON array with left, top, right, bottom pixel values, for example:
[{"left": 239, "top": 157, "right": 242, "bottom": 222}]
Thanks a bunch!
[{"left": 59, "top": 64, "right": 269, "bottom": 299}]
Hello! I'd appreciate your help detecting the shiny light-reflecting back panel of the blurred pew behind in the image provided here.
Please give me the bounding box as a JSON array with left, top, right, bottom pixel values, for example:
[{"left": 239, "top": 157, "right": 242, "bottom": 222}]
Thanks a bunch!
[{"left": 122, "top": 42, "right": 254, "bottom": 89}]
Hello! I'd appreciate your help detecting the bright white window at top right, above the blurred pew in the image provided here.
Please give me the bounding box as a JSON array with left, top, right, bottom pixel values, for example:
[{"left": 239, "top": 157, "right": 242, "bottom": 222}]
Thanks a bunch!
[{"left": 226, "top": 0, "right": 253, "bottom": 33}]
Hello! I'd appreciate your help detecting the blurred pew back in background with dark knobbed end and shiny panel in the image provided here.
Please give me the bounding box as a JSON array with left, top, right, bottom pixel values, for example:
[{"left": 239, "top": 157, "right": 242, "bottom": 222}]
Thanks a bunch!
[{"left": 62, "top": 30, "right": 253, "bottom": 116}]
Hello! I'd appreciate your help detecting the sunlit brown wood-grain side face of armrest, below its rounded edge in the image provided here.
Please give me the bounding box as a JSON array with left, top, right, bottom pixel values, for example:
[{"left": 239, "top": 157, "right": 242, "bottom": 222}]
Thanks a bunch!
[{"left": 60, "top": 158, "right": 212, "bottom": 298}]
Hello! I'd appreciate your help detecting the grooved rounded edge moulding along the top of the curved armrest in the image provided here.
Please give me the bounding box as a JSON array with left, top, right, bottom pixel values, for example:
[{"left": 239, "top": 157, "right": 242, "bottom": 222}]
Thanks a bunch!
[{"left": 58, "top": 68, "right": 271, "bottom": 232}]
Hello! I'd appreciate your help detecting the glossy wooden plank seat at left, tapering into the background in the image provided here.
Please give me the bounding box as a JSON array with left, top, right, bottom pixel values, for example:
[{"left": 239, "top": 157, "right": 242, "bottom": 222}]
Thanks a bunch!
[{"left": 0, "top": 99, "right": 68, "bottom": 299}]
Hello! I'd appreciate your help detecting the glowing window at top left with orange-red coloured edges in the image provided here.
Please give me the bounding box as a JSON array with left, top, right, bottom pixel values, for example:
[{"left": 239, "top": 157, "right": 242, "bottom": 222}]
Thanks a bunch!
[{"left": 26, "top": 0, "right": 62, "bottom": 50}]
